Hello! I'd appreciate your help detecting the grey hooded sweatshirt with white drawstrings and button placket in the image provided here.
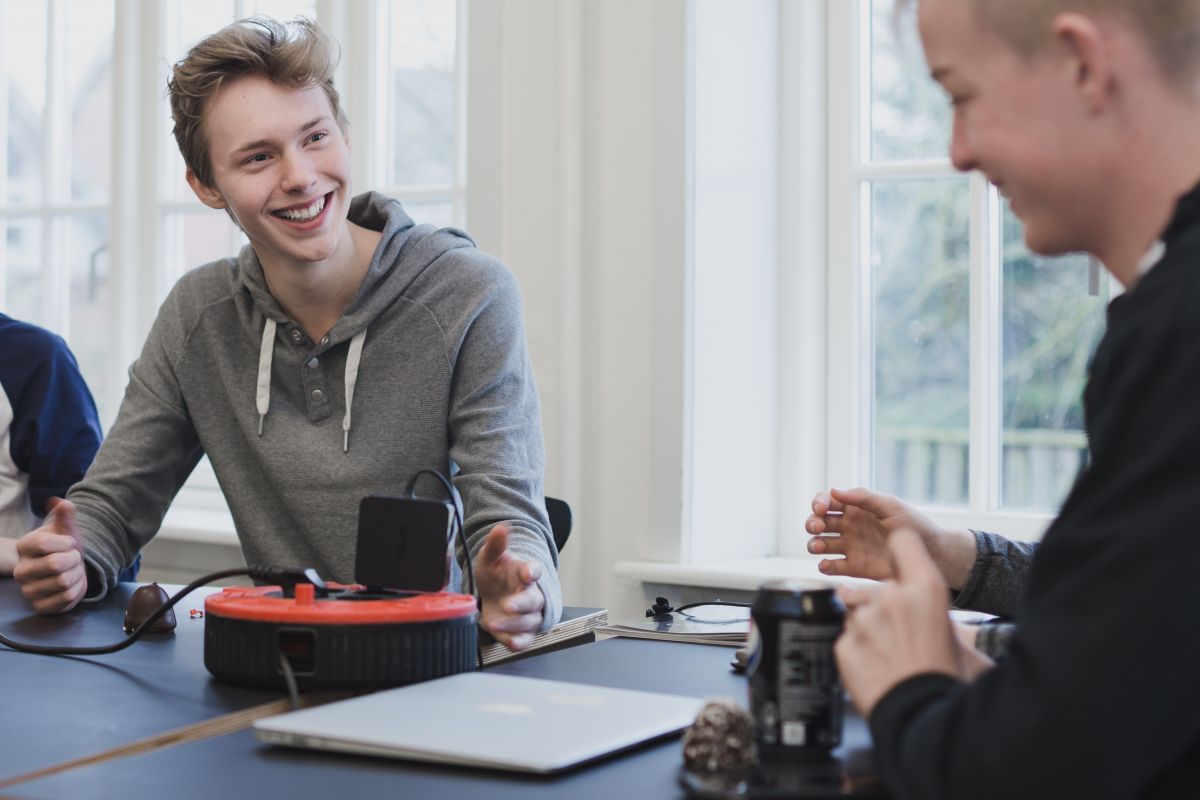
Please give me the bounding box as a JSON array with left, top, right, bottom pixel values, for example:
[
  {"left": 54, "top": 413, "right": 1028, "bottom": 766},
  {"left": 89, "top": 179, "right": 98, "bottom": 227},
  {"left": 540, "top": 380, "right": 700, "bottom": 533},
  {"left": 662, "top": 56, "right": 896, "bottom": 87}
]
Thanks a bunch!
[{"left": 68, "top": 193, "right": 562, "bottom": 627}]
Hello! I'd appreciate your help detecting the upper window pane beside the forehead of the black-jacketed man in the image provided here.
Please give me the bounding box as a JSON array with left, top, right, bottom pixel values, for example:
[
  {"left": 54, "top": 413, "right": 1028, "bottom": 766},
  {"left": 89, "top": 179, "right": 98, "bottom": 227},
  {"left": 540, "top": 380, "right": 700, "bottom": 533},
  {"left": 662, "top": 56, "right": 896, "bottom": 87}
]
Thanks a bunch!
[{"left": 870, "top": 0, "right": 950, "bottom": 161}]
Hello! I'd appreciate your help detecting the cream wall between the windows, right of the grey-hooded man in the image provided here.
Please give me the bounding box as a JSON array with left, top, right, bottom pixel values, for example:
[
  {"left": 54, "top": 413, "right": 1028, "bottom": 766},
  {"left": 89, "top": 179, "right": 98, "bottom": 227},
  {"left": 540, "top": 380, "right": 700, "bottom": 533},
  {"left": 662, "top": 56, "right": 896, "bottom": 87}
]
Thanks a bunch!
[{"left": 468, "top": 0, "right": 688, "bottom": 612}]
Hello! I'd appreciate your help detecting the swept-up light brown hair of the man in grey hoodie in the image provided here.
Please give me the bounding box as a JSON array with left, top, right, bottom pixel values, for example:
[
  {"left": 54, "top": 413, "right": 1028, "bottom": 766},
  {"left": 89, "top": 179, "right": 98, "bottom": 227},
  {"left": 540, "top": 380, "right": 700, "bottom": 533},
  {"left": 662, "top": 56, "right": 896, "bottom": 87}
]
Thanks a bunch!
[{"left": 167, "top": 17, "right": 349, "bottom": 186}]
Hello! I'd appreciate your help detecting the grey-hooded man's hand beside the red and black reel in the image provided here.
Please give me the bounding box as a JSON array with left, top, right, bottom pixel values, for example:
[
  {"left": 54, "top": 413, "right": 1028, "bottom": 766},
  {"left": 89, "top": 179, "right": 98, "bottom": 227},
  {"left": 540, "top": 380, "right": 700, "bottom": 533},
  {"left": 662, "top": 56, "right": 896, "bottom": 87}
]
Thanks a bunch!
[{"left": 474, "top": 522, "right": 546, "bottom": 650}]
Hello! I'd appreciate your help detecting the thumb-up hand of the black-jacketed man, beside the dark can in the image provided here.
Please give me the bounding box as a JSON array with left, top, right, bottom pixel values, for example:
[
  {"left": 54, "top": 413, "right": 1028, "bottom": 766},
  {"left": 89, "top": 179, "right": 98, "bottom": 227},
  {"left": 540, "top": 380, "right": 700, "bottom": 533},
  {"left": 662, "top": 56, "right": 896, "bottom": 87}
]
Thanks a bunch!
[{"left": 834, "top": 529, "right": 965, "bottom": 717}]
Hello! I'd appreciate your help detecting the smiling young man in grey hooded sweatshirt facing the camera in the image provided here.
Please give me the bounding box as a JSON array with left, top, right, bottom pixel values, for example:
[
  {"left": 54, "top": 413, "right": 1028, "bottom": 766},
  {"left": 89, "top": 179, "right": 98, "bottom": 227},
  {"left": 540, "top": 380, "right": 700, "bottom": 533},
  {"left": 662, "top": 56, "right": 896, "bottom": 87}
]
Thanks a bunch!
[{"left": 14, "top": 19, "right": 562, "bottom": 649}]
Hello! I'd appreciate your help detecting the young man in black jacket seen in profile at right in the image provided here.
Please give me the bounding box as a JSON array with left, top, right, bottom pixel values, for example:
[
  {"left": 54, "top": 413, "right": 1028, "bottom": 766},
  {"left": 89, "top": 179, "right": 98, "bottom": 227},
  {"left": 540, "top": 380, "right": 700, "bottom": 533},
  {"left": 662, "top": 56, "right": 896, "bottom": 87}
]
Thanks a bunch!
[{"left": 836, "top": 0, "right": 1200, "bottom": 798}]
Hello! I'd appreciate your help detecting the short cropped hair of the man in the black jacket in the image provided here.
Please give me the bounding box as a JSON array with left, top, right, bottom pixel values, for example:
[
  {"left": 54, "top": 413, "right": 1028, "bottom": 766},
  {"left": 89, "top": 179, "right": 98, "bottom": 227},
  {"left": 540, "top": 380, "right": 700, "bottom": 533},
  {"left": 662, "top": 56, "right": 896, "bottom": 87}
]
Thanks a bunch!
[{"left": 896, "top": 0, "right": 1200, "bottom": 86}]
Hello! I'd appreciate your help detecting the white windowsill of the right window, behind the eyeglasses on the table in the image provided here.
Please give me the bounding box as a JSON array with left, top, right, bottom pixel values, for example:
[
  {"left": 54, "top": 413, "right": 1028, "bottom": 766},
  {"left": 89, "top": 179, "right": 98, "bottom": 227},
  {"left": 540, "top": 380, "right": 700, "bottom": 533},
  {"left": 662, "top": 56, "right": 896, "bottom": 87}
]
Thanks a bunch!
[{"left": 614, "top": 555, "right": 874, "bottom": 591}]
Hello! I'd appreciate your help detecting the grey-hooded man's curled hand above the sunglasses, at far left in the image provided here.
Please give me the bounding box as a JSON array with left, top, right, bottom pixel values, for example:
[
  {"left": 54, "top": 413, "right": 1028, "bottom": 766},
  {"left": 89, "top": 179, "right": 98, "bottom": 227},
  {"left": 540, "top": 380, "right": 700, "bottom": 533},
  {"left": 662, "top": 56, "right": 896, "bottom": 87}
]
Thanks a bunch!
[{"left": 12, "top": 499, "right": 88, "bottom": 614}]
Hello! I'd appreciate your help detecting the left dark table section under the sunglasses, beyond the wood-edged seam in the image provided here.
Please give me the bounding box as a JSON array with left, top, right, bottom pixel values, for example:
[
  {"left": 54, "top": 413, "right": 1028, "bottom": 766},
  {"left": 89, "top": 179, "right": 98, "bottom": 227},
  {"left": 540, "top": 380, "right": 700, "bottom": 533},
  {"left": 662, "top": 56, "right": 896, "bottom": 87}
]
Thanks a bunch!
[{"left": 0, "top": 579, "right": 282, "bottom": 782}]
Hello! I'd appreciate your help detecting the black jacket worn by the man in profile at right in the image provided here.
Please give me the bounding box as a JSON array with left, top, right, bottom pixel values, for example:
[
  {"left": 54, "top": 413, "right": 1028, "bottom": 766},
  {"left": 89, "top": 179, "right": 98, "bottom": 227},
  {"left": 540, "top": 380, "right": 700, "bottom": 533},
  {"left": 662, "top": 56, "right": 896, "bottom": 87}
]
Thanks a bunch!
[{"left": 871, "top": 188, "right": 1200, "bottom": 799}]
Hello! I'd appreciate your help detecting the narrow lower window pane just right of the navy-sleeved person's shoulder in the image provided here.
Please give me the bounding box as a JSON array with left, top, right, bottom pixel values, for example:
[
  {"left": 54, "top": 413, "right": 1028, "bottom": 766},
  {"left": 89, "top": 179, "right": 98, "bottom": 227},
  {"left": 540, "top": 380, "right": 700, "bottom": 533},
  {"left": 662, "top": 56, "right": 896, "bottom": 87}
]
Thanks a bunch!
[{"left": 61, "top": 213, "right": 113, "bottom": 427}]
